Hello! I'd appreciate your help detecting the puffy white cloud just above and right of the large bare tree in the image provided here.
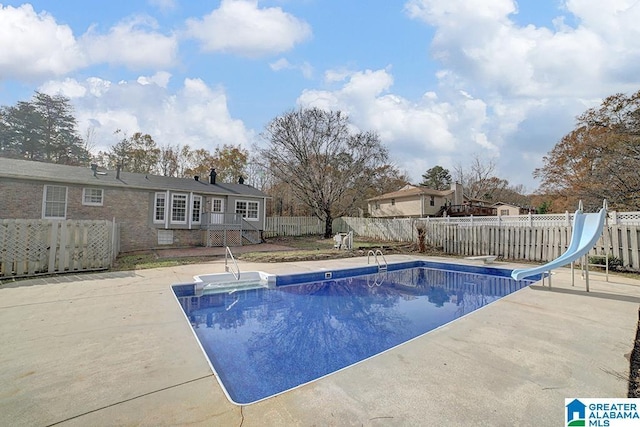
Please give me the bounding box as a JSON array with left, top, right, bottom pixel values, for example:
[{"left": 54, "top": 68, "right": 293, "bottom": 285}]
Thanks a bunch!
[{"left": 298, "top": 70, "right": 497, "bottom": 182}]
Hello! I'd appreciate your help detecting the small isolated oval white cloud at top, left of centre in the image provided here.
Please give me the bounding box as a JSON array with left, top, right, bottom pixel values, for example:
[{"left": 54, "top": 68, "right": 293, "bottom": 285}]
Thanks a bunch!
[{"left": 186, "top": 0, "right": 311, "bottom": 57}]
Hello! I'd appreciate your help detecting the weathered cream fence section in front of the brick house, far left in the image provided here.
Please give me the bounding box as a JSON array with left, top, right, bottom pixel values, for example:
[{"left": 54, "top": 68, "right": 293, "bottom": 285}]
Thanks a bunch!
[{"left": 0, "top": 219, "right": 120, "bottom": 279}]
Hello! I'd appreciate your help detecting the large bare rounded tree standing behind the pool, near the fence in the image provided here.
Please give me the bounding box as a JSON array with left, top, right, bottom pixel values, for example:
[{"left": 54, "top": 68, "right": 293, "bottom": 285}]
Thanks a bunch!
[{"left": 258, "top": 108, "right": 388, "bottom": 238}]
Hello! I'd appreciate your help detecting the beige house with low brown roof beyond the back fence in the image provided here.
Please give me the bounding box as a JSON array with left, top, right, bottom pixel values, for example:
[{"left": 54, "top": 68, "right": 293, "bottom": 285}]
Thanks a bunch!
[{"left": 367, "top": 183, "right": 465, "bottom": 218}]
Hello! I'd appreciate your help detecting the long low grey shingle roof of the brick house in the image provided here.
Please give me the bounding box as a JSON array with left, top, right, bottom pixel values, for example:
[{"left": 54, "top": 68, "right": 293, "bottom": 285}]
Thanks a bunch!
[{"left": 0, "top": 157, "right": 268, "bottom": 197}]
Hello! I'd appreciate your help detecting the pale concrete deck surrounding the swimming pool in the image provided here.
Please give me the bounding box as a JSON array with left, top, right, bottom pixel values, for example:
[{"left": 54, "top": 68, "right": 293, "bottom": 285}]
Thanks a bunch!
[{"left": 0, "top": 255, "right": 640, "bottom": 427}]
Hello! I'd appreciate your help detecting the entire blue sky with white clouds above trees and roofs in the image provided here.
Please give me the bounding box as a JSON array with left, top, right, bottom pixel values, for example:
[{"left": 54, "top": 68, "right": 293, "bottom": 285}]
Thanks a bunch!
[{"left": 0, "top": 0, "right": 640, "bottom": 192}]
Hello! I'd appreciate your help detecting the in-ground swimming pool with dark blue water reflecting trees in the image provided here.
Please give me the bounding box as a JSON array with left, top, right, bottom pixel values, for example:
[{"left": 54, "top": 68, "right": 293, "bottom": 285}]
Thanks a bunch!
[{"left": 173, "top": 261, "right": 535, "bottom": 404}]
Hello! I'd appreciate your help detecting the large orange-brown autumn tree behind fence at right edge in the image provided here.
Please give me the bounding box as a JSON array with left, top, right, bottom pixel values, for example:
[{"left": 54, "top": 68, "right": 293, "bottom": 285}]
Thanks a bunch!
[{"left": 534, "top": 91, "right": 640, "bottom": 210}]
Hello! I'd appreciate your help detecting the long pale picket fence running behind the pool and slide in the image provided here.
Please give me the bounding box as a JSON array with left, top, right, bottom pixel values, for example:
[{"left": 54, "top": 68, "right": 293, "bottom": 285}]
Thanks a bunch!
[{"left": 267, "top": 212, "right": 640, "bottom": 269}]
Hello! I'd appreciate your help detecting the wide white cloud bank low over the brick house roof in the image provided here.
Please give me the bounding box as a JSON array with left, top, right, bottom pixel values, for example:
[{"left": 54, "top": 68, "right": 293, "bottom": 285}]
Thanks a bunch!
[{"left": 39, "top": 76, "right": 255, "bottom": 155}]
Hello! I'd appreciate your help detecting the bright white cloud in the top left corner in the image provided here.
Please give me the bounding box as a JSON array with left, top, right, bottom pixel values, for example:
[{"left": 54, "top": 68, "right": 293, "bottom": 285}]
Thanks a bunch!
[{"left": 0, "top": 4, "right": 86, "bottom": 80}]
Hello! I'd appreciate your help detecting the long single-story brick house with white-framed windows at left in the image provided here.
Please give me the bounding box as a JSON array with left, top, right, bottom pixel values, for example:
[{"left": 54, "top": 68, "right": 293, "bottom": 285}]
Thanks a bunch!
[{"left": 0, "top": 157, "right": 267, "bottom": 252}]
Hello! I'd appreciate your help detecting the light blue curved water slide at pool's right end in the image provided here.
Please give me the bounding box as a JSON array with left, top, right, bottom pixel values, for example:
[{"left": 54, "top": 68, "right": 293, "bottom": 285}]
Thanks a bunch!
[{"left": 511, "top": 200, "right": 607, "bottom": 280}]
